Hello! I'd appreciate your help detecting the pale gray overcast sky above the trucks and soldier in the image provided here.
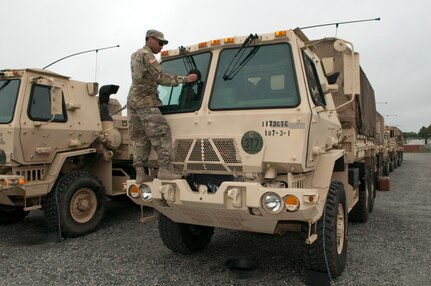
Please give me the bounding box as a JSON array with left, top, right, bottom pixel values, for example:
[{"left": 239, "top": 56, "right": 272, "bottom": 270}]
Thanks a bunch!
[{"left": 0, "top": 0, "right": 431, "bottom": 132}]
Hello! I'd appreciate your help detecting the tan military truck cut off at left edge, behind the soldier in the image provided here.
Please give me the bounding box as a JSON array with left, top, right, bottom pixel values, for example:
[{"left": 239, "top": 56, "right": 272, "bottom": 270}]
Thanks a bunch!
[{"left": 0, "top": 69, "right": 134, "bottom": 237}]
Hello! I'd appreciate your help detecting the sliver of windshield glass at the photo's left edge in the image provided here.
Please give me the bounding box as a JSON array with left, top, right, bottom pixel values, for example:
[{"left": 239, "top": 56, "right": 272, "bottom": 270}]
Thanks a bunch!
[{"left": 0, "top": 79, "right": 19, "bottom": 124}]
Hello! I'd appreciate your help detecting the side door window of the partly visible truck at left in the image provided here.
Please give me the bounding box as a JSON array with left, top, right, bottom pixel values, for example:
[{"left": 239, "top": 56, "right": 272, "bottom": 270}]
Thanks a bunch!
[{"left": 28, "top": 84, "right": 67, "bottom": 122}]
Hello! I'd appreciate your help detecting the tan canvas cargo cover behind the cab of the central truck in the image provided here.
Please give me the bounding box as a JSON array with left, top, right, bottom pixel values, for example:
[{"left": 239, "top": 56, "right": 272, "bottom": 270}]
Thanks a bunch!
[{"left": 313, "top": 38, "right": 376, "bottom": 138}]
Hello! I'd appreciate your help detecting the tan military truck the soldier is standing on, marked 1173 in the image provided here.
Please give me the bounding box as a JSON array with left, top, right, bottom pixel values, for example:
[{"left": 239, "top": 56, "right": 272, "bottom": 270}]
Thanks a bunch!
[{"left": 127, "top": 29, "right": 376, "bottom": 277}]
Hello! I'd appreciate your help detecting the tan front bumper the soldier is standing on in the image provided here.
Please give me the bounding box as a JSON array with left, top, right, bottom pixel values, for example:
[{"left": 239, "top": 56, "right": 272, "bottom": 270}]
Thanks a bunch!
[{"left": 127, "top": 179, "right": 325, "bottom": 234}]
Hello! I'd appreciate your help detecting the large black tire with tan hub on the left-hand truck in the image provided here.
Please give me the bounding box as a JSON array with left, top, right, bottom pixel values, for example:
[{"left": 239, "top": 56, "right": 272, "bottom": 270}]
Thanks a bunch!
[{"left": 44, "top": 171, "right": 107, "bottom": 237}]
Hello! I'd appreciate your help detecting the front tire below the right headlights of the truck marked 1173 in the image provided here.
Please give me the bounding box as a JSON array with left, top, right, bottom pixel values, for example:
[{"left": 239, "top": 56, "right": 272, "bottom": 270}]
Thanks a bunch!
[{"left": 301, "top": 181, "right": 347, "bottom": 278}]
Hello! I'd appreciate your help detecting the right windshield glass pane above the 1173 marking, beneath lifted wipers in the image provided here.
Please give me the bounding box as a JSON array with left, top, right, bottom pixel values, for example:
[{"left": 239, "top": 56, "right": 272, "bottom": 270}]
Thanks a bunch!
[{"left": 209, "top": 43, "right": 299, "bottom": 110}]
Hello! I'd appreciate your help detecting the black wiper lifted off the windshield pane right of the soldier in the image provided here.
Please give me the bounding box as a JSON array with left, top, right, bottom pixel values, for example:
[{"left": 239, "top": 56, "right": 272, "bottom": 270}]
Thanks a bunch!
[{"left": 223, "top": 34, "right": 260, "bottom": 81}]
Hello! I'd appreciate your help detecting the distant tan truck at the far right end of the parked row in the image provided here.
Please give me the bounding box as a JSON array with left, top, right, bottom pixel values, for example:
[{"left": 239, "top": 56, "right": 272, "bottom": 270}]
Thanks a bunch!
[{"left": 385, "top": 125, "right": 404, "bottom": 172}]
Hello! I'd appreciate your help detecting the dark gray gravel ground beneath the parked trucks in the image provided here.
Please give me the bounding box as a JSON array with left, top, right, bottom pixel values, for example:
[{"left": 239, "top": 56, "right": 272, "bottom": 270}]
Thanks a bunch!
[{"left": 0, "top": 154, "right": 431, "bottom": 285}]
